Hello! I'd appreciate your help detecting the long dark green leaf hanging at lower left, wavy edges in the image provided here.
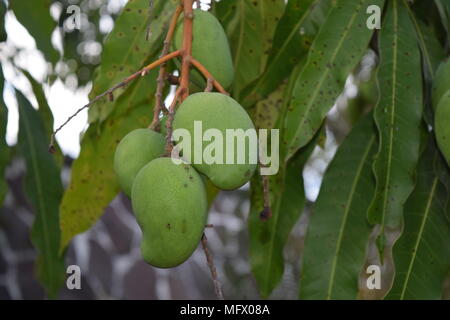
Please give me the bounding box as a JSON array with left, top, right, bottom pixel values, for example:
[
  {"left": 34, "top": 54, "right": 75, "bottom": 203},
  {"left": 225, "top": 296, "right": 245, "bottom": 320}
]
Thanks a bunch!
[{"left": 16, "top": 92, "right": 66, "bottom": 298}]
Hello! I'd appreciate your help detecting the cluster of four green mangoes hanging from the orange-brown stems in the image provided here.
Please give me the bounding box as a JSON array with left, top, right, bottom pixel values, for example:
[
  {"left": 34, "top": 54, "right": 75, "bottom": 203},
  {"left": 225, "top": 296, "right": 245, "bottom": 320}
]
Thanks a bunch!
[{"left": 114, "top": 10, "right": 256, "bottom": 268}]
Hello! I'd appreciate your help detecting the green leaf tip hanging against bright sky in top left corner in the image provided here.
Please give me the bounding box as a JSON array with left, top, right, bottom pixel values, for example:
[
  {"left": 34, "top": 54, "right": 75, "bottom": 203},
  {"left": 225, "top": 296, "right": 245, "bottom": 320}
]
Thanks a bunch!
[{"left": 9, "top": 0, "right": 59, "bottom": 64}]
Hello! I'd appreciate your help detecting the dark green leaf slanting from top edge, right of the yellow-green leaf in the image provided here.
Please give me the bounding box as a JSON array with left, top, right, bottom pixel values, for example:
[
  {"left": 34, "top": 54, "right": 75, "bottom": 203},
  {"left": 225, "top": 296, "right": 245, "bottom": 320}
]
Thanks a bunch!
[{"left": 242, "top": 0, "right": 330, "bottom": 107}]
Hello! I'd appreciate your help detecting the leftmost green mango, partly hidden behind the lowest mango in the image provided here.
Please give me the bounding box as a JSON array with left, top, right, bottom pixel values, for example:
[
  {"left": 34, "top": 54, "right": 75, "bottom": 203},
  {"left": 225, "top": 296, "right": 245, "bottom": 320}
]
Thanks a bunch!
[{"left": 114, "top": 129, "right": 166, "bottom": 196}]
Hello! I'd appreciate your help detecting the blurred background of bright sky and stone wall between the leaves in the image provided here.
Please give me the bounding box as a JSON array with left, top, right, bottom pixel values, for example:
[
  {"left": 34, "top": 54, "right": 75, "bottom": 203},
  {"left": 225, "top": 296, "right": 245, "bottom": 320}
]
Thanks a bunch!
[{"left": 0, "top": 0, "right": 400, "bottom": 299}]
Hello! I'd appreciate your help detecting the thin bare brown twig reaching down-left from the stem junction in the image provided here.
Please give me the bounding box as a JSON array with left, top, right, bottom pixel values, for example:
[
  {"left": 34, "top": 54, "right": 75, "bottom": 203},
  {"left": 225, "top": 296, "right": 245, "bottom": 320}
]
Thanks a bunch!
[{"left": 49, "top": 50, "right": 181, "bottom": 152}]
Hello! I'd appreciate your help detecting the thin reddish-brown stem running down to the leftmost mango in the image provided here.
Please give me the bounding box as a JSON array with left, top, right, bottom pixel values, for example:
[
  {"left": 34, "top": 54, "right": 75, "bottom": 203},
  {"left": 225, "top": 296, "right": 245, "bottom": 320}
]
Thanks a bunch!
[{"left": 149, "top": 5, "right": 183, "bottom": 130}]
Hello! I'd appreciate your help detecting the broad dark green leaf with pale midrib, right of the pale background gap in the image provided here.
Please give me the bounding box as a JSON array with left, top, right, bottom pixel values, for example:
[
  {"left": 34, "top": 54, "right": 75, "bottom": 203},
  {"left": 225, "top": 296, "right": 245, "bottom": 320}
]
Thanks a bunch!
[{"left": 300, "top": 114, "right": 377, "bottom": 300}]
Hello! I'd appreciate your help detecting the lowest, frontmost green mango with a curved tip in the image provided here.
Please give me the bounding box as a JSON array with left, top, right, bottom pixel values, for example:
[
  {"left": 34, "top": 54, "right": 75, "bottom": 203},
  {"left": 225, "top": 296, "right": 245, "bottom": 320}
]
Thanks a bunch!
[{"left": 131, "top": 158, "right": 208, "bottom": 268}]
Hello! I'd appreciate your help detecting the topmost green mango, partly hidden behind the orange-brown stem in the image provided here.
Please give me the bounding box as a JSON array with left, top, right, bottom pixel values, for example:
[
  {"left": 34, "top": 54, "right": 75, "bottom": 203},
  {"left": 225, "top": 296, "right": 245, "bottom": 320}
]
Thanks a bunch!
[{"left": 174, "top": 10, "right": 234, "bottom": 88}]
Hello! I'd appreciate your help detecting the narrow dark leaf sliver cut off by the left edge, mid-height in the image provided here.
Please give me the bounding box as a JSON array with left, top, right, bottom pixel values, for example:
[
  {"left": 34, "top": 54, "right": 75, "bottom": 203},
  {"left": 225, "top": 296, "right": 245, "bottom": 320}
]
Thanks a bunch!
[{"left": 0, "top": 68, "right": 10, "bottom": 205}]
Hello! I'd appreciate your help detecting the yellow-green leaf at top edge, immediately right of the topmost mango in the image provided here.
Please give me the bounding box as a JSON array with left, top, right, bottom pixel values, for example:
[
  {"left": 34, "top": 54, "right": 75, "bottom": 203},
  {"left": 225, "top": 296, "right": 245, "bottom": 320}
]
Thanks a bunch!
[{"left": 215, "top": 0, "right": 285, "bottom": 100}]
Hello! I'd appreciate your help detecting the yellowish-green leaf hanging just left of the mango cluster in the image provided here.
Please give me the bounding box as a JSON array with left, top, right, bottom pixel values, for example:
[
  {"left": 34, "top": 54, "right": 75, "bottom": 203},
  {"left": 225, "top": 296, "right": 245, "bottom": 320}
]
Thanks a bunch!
[{"left": 60, "top": 70, "right": 157, "bottom": 250}]
